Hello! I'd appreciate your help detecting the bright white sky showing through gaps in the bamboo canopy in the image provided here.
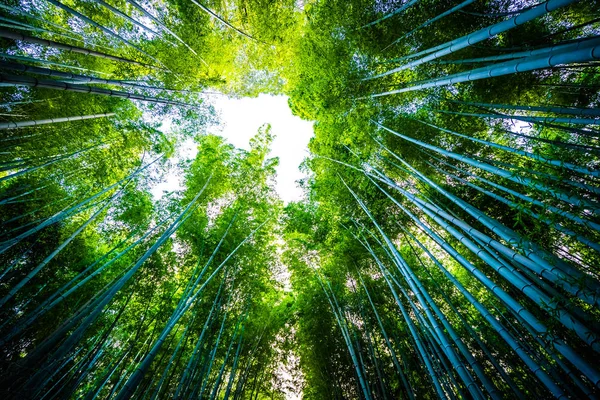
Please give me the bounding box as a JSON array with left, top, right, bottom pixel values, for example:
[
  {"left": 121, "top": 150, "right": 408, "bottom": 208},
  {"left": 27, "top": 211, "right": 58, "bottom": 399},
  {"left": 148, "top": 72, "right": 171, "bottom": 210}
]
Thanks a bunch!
[{"left": 152, "top": 94, "right": 313, "bottom": 203}]
